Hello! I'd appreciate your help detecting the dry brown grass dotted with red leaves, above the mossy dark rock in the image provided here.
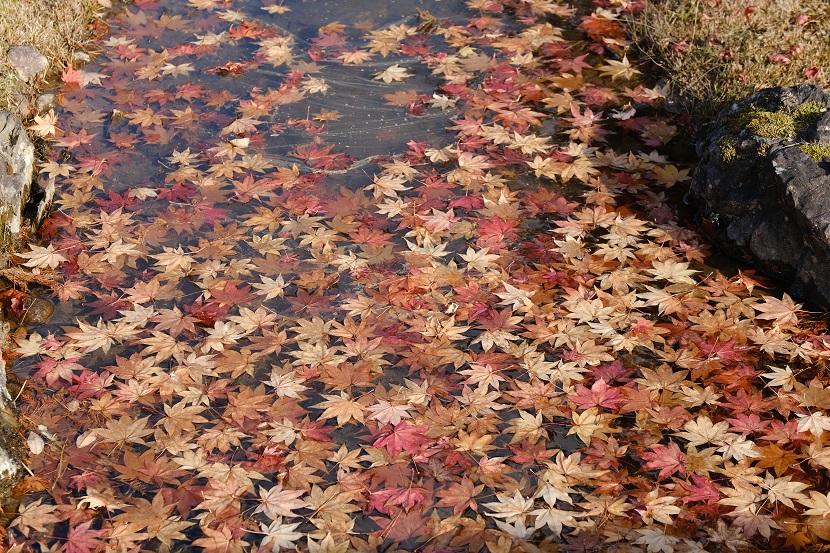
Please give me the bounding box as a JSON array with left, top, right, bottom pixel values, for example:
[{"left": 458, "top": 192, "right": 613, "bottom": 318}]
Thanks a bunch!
[{"left": 631, "top": 0, "right": 830, "bottom": 117}]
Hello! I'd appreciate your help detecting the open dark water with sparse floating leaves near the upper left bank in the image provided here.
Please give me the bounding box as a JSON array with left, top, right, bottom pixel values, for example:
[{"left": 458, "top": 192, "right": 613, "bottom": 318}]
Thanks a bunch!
[{"left": 61, "top": 0, "right": 468, "bottom": 192}]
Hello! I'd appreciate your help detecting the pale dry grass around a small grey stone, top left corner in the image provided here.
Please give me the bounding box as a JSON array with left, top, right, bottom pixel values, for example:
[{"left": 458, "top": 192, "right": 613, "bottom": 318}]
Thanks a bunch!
[{"left": 0, "top": 0, "right": 100, "bottom": 116}]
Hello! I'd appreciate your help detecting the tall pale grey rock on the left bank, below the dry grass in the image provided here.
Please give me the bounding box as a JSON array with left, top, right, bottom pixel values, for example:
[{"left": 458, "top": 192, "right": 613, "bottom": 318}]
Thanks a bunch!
[{"left": 0, "top": 111, "right": 54, "bottom": 247}]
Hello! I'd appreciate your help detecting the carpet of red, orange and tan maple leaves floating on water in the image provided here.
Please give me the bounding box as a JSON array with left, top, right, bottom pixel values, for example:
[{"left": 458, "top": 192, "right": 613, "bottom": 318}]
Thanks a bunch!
[{"left": 7, "top": 0, "right": 830, "bottom": 553}]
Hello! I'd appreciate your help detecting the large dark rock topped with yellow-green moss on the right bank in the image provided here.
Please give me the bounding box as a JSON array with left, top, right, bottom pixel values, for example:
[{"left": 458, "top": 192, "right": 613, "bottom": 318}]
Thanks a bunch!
[{"left": 690, "top": 85, "right": 830, "bottom": 307}]
